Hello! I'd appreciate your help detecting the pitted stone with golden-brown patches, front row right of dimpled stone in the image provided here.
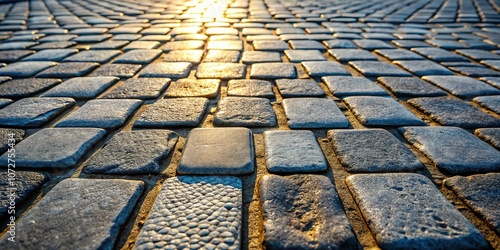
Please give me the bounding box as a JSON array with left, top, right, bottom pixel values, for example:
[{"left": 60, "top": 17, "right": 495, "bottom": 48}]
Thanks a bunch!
[{"left": 259, "top": 175, "right": 357, "bottom": 249}]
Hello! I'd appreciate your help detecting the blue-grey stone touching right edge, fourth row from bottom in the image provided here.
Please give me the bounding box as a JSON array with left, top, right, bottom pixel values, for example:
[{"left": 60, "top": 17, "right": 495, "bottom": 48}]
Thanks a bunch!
[{"left": 422, "top": 76, "right": 500, "bottom": 98}]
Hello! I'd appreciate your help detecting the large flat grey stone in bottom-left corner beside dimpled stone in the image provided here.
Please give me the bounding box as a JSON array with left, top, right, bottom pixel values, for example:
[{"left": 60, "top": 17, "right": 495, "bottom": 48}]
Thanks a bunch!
[{"left": 0, "top": 178, "right": 144, "bottom": 249}]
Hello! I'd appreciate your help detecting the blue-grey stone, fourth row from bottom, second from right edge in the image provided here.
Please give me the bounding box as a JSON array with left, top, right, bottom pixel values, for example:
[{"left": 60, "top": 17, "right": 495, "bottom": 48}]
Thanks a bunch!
[{"left": 377, "top": 77, "right": 446, "bottom": 97}]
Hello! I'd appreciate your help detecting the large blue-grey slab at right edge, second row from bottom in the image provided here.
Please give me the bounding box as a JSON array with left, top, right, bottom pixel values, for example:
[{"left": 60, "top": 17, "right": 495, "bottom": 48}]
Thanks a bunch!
[{"left": 400, "top": 127, "right": 500, "bottom": 175}]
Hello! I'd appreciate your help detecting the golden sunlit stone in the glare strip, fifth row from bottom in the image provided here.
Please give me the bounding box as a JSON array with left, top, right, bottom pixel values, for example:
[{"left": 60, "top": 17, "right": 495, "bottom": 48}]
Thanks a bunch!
[{"left": 196, "top": 63, "right": 246, "bottom": 79}]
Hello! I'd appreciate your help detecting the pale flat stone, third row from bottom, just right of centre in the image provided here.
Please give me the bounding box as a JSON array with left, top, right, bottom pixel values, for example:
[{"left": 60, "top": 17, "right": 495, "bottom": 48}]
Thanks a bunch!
[{"left": 283, "top": 98, "right": 349, "bottom": 129}]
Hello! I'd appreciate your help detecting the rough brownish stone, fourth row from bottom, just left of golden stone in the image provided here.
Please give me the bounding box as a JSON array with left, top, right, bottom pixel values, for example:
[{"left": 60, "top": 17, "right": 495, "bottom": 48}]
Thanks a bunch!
[{"left": 103, "top": 78, "right": 170, "bottom": 99}]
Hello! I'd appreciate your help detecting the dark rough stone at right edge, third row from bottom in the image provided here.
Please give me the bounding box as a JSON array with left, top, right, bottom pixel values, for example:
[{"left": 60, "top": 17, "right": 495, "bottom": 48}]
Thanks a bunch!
[{"left": 408, "top": 97, "right": 500, "bottom": 128}]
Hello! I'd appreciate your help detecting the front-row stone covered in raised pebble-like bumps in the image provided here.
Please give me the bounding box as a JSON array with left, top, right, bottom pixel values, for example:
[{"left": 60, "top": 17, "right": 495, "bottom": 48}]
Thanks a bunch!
[{"left": 134, "top": 176, "right": 242, "bottom": 250}]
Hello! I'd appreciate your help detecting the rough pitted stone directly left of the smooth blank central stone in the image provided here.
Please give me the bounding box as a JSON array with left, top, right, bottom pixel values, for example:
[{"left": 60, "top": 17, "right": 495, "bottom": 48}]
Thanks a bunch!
[{"left": 83, "top": 130, "right": 179, "bottom": 174}]
